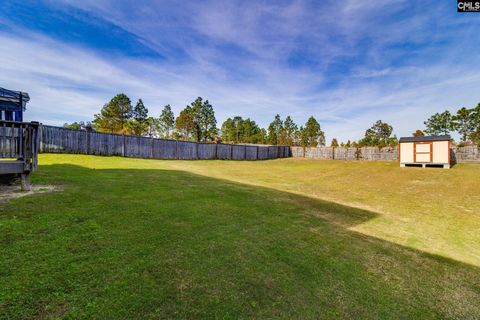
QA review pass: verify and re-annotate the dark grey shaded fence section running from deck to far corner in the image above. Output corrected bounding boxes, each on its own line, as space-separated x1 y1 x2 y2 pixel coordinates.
40 125 290 160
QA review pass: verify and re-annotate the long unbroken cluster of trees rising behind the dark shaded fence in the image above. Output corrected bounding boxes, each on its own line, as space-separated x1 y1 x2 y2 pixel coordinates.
64 93 325 147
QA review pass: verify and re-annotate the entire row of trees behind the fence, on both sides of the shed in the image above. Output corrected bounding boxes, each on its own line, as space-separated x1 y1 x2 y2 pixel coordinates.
64 93 480 147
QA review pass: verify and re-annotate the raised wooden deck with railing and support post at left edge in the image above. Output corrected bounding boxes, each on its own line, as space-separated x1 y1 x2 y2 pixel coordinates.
0 121 39 190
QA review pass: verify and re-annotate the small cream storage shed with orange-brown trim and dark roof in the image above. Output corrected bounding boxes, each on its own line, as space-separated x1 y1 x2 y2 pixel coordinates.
398 135 451 169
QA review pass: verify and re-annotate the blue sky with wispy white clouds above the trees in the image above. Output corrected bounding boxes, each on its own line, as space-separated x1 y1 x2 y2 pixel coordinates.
0 0 480 141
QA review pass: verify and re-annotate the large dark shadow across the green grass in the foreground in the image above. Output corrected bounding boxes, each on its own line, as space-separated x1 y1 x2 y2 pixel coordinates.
0 165 480 319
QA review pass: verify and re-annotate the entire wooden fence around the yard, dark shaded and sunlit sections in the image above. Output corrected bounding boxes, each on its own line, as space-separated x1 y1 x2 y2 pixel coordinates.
34 125 480 163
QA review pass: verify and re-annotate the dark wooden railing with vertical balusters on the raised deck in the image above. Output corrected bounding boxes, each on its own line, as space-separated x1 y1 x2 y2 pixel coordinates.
0 120 40 172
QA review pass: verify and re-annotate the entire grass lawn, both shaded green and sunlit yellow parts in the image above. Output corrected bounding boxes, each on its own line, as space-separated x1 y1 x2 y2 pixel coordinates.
0 155 480 319
